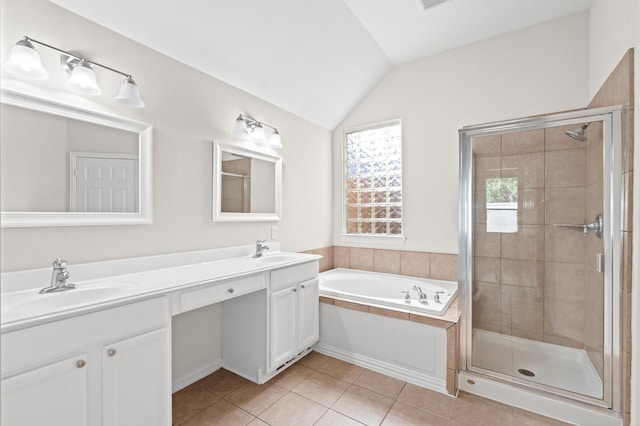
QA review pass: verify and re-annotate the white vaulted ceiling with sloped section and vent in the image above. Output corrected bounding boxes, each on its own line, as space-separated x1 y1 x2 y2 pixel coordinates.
51 0 591 129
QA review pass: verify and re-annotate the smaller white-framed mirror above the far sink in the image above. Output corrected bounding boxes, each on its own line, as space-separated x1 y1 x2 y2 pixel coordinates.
213 141 282 222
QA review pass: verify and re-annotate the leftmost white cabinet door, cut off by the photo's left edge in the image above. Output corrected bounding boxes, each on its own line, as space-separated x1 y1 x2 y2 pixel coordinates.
2 353 89 426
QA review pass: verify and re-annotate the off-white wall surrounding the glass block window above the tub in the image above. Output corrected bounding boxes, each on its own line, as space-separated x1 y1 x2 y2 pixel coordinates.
333 12 589 253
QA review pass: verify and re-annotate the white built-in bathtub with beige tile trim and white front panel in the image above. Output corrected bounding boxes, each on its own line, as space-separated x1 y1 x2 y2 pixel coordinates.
314 268 459 394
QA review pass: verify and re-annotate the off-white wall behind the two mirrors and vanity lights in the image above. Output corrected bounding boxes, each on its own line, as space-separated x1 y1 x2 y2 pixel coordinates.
0 0 332 271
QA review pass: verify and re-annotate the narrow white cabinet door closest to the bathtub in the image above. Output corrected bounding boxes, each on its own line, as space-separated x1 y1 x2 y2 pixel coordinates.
298 278 320 351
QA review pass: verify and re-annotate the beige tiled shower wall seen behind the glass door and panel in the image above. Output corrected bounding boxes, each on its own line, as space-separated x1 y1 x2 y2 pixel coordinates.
473 126 602 364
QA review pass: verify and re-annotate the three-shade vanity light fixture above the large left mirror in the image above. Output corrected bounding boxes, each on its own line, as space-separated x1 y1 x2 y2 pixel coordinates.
4 36 144 108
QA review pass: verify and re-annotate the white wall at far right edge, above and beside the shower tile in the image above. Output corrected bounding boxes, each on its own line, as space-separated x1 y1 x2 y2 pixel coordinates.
589 0 640 425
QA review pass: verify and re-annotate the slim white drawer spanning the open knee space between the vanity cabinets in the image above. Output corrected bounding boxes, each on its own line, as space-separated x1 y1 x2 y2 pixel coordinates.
172 274 266 315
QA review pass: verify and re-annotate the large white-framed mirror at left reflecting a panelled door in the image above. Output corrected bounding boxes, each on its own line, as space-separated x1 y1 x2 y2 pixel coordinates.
0 89 153 227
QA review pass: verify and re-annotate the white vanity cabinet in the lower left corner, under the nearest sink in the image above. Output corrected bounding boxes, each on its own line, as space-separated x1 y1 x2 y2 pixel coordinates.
1 297 171 426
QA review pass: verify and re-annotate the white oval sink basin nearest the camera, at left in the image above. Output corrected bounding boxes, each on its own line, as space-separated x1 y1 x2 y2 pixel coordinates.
3 282 134 312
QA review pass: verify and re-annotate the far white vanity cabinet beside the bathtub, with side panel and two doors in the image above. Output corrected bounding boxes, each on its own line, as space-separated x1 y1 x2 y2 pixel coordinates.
222 259 319 384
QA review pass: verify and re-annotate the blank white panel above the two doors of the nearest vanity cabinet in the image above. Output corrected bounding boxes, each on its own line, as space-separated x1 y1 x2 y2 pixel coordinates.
1 296 170 379
